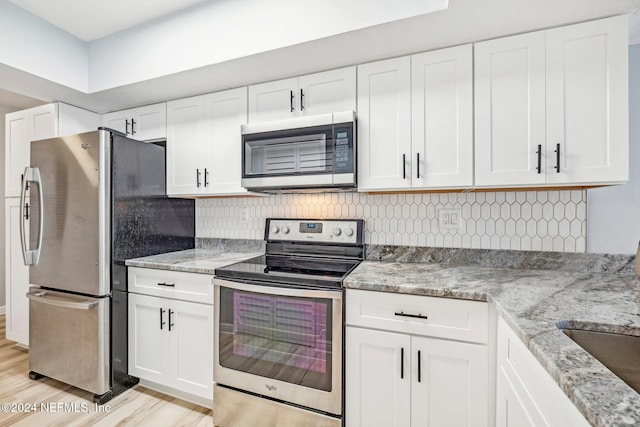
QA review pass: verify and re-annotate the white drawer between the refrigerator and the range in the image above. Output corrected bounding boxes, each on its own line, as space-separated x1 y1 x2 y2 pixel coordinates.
128 267 213 305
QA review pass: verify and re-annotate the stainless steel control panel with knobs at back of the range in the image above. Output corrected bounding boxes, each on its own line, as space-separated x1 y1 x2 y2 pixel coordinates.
265 218 363 245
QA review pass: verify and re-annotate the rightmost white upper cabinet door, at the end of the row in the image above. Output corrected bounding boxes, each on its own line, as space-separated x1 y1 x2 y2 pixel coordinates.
547 16 629 184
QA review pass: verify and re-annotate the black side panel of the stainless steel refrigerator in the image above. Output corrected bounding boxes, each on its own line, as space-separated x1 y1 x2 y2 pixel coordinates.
111 132 195 394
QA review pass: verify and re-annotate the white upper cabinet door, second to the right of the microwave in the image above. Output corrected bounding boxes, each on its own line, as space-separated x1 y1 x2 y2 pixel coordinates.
411 45 473 188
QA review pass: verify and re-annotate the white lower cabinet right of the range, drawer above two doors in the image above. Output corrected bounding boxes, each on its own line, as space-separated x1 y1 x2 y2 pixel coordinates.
345 289 493 427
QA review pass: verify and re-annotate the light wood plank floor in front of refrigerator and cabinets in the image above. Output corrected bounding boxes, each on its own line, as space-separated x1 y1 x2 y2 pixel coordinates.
0 315 213 427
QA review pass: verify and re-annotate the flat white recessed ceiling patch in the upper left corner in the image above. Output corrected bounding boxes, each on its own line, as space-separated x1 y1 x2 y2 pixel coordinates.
9 0 207 41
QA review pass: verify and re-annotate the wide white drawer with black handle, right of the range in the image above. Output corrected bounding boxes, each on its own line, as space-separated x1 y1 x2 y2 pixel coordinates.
346 289 489 344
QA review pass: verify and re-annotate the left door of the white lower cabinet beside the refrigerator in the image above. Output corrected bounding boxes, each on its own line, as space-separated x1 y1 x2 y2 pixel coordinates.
129 293 170 384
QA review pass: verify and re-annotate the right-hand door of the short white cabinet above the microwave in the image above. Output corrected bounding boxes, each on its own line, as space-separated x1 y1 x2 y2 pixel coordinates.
297 67 356 116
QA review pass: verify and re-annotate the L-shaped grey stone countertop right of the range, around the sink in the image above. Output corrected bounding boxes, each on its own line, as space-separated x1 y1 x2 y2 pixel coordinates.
345 261 640 426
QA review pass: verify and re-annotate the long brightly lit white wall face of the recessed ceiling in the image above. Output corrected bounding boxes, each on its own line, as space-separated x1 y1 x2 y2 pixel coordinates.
89 0 448 92
